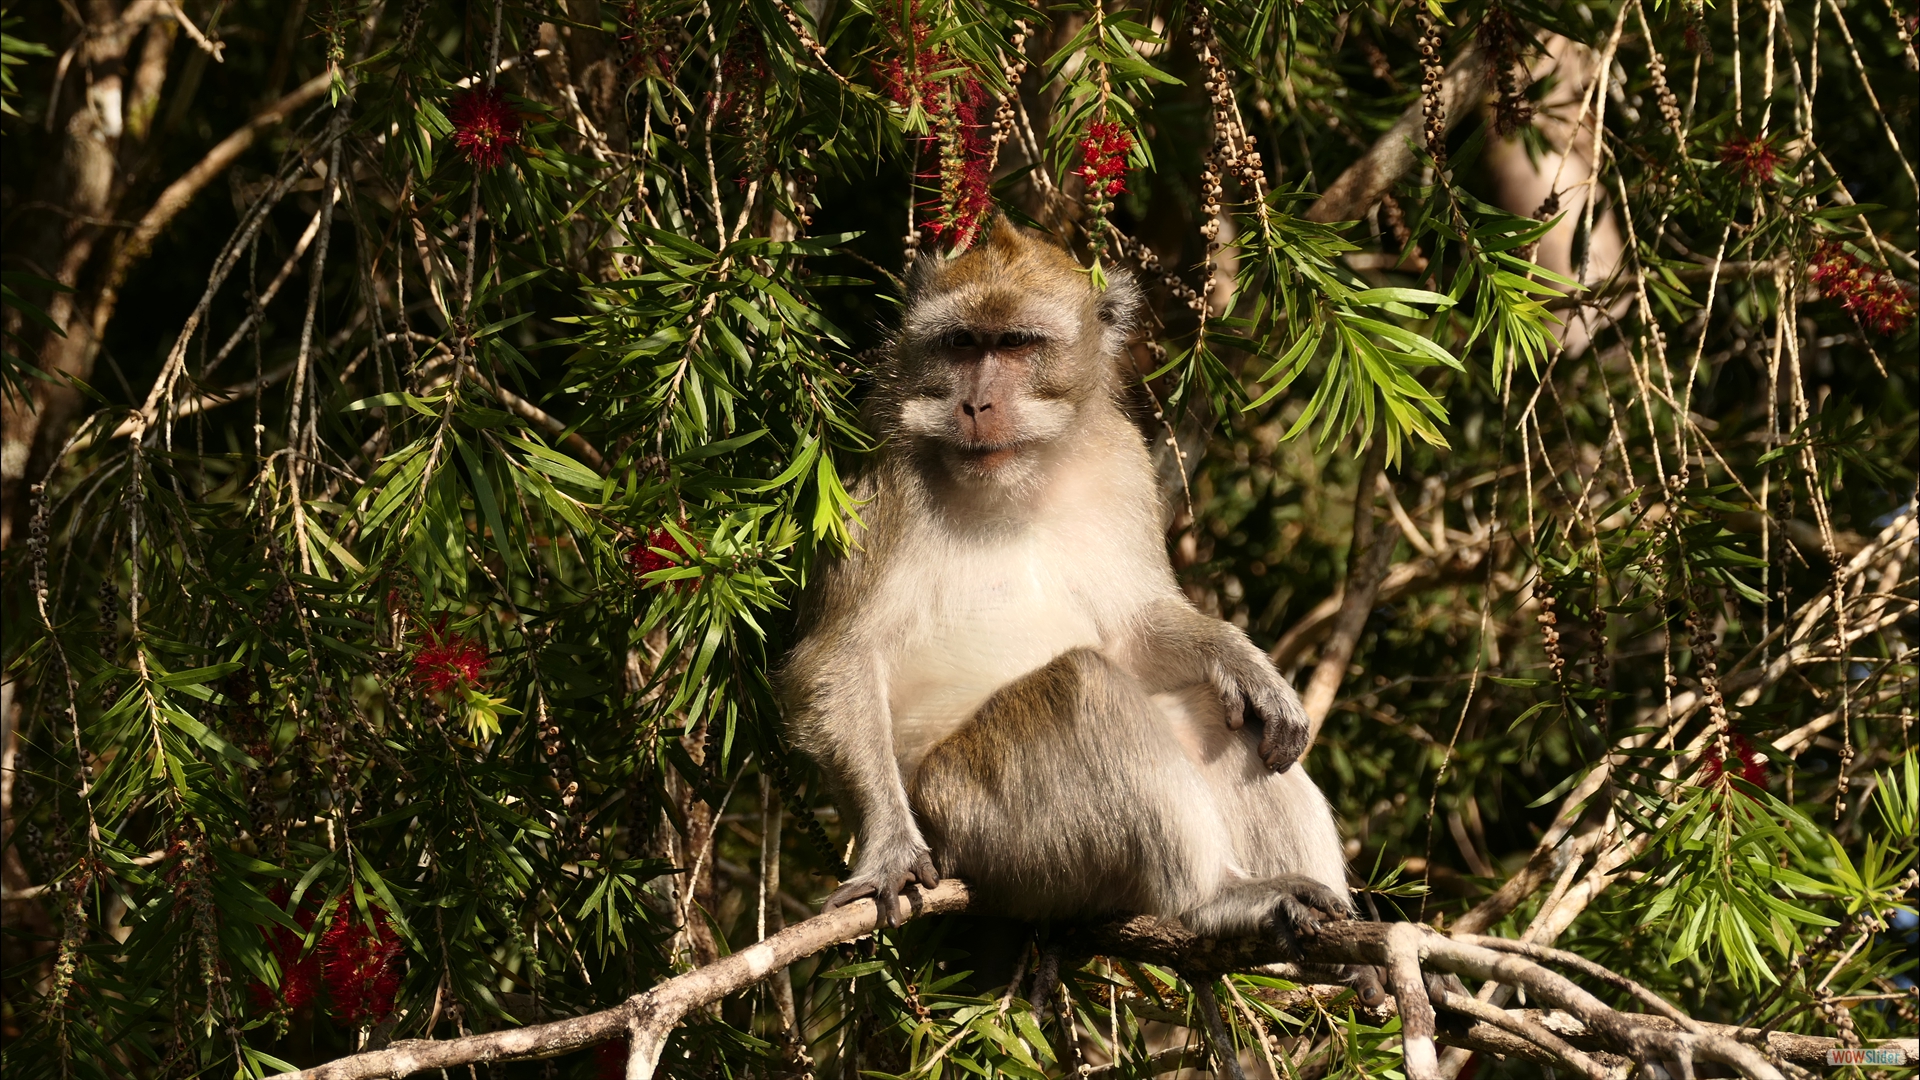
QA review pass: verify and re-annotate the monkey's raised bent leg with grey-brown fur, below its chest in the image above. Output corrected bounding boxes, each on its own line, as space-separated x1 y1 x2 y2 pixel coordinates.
910 650 1233 919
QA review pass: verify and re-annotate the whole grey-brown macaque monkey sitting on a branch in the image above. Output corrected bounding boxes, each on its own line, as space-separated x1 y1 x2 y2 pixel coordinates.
781 219 1379 968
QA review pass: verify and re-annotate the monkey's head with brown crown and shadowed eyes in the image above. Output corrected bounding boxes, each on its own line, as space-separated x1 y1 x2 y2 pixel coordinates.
881 217 1139 484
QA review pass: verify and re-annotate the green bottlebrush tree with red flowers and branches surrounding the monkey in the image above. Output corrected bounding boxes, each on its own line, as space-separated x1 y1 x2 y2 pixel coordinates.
0 0 1920 1080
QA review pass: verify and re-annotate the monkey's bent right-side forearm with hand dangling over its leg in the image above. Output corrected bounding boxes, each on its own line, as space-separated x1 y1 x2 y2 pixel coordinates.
1123 596 1309 773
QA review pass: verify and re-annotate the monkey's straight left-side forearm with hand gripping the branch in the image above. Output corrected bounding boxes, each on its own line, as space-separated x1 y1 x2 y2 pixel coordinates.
785 634 941 922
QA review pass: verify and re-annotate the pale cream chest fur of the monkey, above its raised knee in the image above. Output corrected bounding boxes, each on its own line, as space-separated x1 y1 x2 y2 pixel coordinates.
876 530 1150 776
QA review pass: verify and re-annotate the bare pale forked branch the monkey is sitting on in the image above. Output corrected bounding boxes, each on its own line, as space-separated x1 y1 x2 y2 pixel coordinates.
259 880 1920 1080
